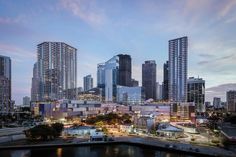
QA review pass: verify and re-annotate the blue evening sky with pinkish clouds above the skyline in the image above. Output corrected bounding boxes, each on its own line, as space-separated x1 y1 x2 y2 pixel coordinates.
0 0 236 104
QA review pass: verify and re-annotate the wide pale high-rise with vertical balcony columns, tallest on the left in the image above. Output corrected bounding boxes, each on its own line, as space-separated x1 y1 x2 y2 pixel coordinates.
37 42 77 101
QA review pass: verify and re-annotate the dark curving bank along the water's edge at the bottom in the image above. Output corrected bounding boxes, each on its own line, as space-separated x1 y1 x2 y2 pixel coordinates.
0 137 233 157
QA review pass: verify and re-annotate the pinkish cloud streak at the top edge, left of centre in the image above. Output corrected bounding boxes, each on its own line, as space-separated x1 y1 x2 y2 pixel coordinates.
61 0 105 26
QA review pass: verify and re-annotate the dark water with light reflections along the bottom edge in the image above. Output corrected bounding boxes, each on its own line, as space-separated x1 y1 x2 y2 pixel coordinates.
0 144 193 157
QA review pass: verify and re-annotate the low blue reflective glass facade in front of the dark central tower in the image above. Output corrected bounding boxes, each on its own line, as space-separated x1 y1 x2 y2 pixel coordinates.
116 86 144 105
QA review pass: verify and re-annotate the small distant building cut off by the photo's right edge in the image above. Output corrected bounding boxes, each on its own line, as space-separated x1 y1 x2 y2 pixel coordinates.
226 90 236 112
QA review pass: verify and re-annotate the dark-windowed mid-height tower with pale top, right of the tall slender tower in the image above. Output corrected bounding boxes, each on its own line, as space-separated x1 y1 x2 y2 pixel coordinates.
187 77 206 112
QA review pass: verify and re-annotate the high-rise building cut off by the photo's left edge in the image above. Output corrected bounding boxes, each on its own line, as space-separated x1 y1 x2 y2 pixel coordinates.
0 55 13 114
